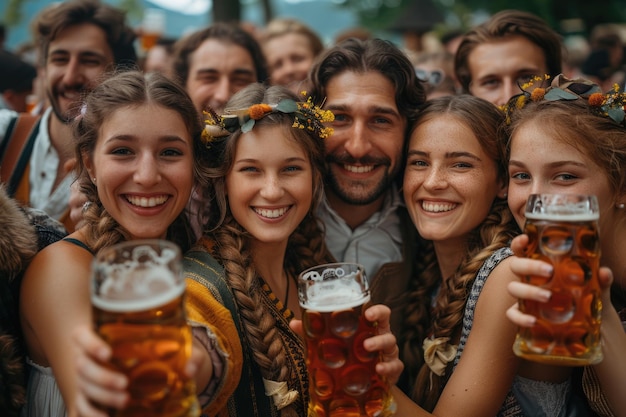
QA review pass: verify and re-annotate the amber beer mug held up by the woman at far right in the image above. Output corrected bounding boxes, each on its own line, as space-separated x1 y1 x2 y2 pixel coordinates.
513 194 603 366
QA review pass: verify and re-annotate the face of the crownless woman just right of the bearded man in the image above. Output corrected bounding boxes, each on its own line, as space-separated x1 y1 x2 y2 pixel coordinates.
403 114 505 244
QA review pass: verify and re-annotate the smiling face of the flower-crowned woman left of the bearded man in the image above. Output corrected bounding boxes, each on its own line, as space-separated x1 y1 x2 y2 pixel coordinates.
226 126 313 247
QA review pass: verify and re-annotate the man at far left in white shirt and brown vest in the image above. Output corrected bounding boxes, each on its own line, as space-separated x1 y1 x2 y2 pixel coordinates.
0 0 136 231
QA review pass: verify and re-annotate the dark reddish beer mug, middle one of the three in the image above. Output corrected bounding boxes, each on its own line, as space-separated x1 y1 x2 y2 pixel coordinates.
298 263 395 417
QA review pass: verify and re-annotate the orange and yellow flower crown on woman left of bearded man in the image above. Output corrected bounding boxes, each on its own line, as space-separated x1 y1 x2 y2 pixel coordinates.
202 91 335 146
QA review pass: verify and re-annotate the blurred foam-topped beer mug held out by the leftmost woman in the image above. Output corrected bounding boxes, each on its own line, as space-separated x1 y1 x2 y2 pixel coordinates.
91 240 200 417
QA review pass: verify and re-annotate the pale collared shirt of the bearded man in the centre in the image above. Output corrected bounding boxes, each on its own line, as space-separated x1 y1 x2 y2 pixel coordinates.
317 186 404 279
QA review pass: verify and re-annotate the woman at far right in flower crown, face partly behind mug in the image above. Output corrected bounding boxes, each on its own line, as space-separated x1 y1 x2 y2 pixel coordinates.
500 75 626 416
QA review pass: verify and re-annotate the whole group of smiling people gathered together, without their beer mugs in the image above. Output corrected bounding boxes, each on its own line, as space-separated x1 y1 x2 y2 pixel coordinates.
0 0 626 417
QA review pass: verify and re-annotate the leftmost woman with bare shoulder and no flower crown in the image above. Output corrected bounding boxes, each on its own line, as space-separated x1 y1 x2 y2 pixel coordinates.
15 71 203 417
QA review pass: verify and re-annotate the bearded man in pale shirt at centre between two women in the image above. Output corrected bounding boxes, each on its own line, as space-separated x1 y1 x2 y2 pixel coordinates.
310 39 425 334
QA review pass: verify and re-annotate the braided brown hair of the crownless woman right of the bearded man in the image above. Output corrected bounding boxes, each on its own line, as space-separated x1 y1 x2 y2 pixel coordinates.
402 95 519 411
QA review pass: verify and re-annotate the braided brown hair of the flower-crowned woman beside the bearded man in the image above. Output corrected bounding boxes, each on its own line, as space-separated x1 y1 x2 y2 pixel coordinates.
205 84 332 417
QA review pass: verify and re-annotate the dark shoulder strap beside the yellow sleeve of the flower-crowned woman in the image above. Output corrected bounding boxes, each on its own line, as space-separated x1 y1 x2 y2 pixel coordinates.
183 250 269 417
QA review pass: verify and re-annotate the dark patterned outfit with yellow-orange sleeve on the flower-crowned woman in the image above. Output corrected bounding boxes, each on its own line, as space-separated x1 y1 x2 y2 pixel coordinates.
184 242 309 417
